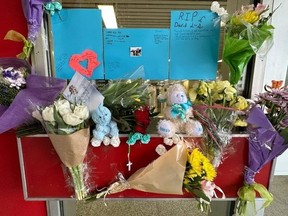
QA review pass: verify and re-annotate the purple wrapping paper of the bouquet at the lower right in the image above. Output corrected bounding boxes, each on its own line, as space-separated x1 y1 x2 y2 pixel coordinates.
244 107 288 184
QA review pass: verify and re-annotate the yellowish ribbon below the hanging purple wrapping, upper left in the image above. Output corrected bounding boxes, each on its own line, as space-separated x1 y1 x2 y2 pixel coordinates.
4 30 33 60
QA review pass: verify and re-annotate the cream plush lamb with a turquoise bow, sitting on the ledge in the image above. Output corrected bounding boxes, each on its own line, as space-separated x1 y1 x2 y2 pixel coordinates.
157 83 203 144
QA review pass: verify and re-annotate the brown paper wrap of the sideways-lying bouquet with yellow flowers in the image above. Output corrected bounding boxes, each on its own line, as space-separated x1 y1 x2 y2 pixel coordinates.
107 141 187 195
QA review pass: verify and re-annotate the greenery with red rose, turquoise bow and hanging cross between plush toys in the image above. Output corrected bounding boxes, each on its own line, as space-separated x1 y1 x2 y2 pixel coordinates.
101 75 158 171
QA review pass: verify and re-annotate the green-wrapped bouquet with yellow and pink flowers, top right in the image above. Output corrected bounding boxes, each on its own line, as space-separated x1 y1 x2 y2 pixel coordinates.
211 2 274 85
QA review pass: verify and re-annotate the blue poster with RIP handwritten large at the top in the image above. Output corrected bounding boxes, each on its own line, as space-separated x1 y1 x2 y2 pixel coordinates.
169 10 220 80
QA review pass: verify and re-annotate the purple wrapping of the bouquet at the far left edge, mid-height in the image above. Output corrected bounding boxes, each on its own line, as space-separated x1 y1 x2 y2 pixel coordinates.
0 75 66 133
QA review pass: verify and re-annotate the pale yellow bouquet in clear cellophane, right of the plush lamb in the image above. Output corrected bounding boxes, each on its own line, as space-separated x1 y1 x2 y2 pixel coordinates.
189 80 248 167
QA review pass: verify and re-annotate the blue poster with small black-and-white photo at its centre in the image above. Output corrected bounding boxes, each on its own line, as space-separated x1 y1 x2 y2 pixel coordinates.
104 28 169 80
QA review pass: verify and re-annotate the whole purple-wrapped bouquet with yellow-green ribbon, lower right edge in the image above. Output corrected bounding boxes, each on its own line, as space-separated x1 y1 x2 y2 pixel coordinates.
236 81 288 216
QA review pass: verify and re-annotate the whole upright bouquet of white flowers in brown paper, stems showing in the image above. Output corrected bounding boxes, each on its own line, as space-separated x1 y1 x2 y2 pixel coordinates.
34 97 90 200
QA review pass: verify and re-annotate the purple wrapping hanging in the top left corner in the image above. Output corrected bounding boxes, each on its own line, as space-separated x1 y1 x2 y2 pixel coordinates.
22 0 52 44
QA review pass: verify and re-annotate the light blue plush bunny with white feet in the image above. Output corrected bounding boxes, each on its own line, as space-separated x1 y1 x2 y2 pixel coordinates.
91 104 120 147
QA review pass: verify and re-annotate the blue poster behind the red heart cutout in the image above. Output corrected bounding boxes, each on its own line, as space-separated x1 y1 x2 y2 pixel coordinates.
51 9 104 79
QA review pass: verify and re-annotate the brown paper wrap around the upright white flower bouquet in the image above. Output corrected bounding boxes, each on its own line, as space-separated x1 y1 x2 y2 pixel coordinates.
48 128 90 167
